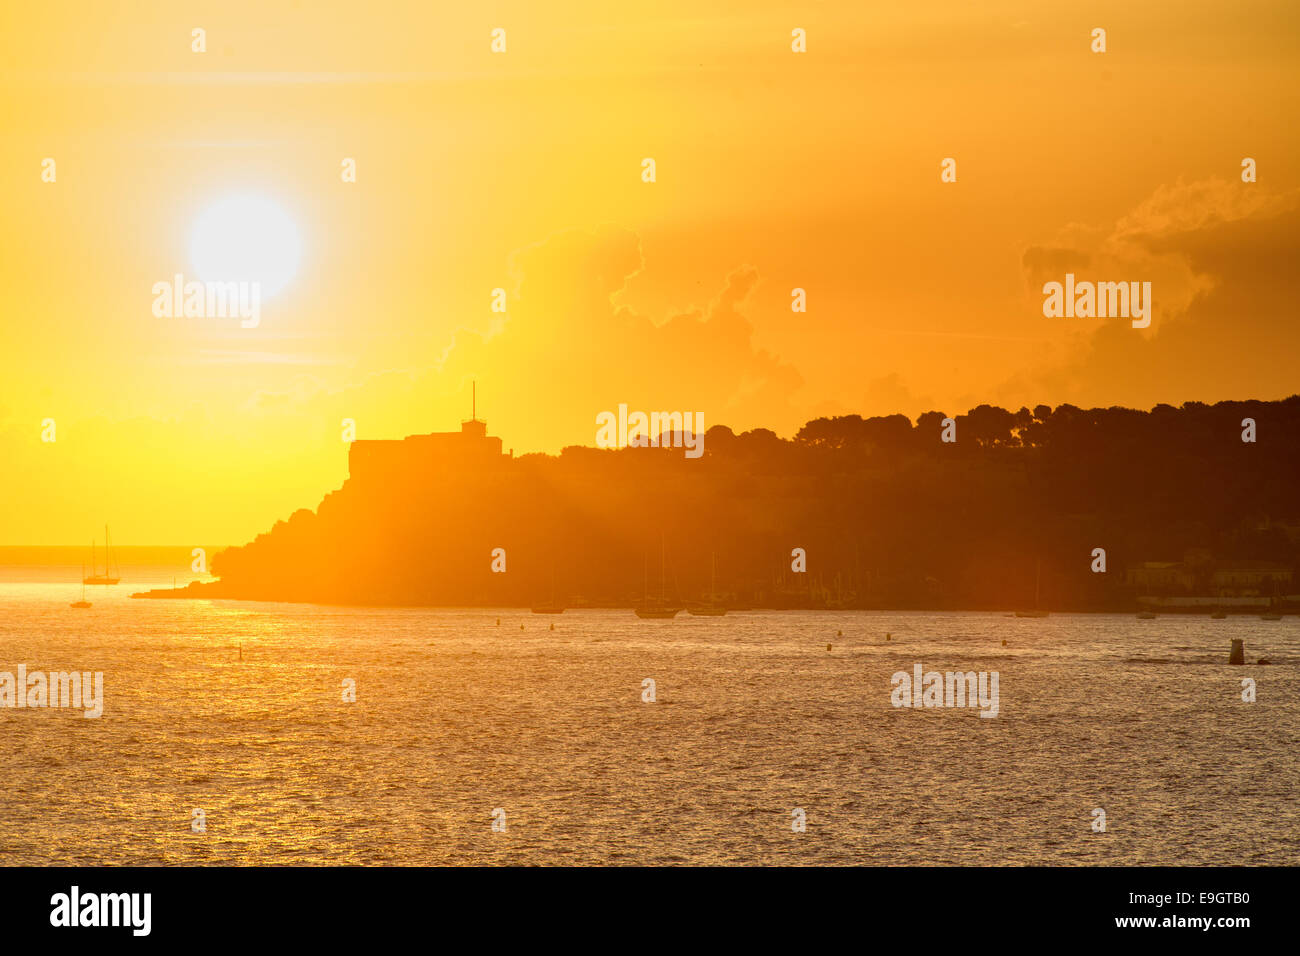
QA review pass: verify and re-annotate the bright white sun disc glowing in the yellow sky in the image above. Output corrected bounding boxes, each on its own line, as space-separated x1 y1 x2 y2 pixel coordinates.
190 196 303 298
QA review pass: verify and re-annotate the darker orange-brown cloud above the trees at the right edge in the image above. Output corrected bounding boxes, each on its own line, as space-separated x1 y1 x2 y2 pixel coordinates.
1019 179 1300 406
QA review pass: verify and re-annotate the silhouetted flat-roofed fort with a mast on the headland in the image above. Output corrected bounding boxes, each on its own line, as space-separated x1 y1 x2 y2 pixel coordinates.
347 385 515 483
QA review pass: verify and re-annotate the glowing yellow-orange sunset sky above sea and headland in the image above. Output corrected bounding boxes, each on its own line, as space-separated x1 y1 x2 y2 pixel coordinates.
0 0 1300 544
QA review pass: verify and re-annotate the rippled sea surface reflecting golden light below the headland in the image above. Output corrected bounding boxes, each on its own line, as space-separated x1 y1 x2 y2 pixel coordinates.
0 567 1300 865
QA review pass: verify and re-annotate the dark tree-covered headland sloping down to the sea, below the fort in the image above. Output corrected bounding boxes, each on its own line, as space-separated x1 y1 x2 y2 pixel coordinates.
211 395 1300 610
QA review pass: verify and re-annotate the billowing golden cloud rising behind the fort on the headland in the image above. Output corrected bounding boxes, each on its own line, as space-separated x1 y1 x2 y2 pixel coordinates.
439 226 802 447
